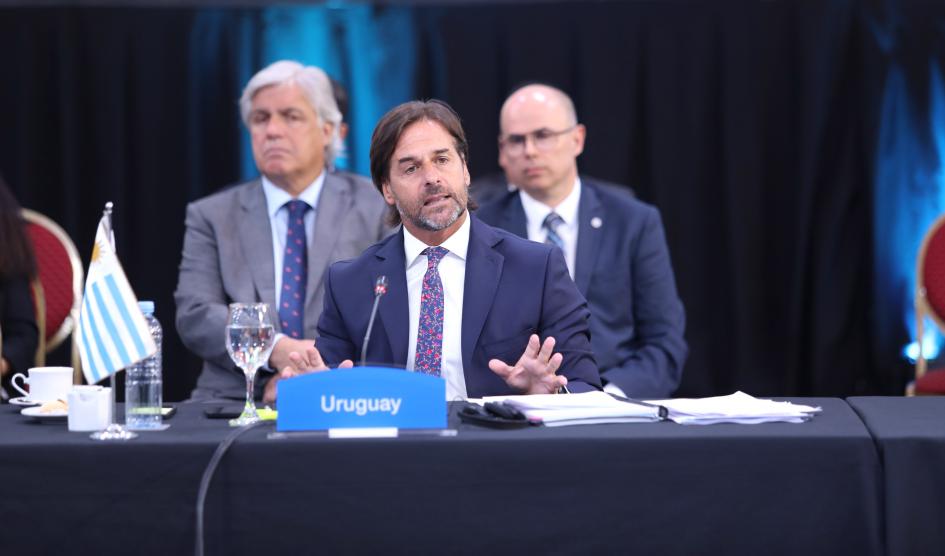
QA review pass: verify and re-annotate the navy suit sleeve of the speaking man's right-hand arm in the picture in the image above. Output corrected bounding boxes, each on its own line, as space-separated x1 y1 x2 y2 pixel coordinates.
540 245 601 393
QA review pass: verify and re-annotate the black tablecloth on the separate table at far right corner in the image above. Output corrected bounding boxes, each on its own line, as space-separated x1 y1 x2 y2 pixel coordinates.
848 396 945 556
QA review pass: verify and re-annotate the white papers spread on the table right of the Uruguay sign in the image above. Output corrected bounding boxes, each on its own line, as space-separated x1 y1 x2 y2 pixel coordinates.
480 392 821 427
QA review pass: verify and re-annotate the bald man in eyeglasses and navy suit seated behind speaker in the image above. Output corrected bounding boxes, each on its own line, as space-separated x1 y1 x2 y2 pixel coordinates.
477 84 688 398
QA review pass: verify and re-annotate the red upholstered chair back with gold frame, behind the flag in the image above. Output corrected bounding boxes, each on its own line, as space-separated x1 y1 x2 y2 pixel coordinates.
23 209 84 383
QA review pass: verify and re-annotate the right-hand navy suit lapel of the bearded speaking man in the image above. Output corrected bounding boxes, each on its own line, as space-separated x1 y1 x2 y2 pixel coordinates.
462 217 506 374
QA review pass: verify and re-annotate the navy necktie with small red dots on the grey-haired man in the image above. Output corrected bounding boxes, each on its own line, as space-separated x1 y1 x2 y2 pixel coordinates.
279 199 312 338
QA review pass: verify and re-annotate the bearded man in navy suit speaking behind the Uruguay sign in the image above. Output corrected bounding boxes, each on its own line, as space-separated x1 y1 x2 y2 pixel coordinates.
269 100 600 400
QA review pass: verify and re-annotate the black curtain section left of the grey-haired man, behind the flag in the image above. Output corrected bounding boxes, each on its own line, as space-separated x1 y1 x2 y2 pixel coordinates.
0 8 254 400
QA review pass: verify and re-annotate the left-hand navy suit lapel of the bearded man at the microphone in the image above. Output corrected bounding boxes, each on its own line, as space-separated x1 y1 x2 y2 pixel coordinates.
369 229 410 364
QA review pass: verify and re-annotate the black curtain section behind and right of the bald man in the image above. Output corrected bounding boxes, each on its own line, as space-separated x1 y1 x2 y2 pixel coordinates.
420 0 878 395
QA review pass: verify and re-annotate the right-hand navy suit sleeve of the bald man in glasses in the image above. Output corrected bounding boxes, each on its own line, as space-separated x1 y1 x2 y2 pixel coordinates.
601 206 688 398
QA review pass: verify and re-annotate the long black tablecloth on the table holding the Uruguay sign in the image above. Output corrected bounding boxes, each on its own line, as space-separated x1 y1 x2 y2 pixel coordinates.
0 399 882 556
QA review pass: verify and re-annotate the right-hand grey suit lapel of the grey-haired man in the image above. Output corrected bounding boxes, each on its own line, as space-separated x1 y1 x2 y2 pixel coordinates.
305 176 350 319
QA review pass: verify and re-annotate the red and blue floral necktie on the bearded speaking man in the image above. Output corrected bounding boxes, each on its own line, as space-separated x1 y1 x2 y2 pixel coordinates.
413 247 449 376
